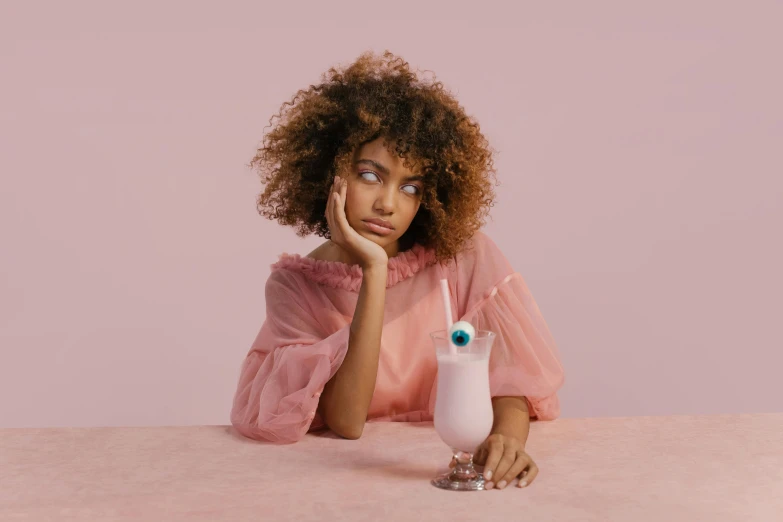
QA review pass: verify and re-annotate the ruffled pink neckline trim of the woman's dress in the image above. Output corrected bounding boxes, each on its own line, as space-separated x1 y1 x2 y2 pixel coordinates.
272 243 436 292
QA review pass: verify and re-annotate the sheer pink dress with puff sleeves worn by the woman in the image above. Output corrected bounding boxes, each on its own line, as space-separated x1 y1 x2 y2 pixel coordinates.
231 232 564 443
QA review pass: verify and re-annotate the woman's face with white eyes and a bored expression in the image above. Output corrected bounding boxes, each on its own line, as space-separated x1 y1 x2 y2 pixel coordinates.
345 138 424 257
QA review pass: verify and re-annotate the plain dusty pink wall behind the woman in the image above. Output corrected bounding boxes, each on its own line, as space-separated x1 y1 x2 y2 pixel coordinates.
0 1 783 427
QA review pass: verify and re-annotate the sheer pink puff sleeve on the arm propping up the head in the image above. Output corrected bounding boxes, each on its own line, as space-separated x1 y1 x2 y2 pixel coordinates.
231 270 350 443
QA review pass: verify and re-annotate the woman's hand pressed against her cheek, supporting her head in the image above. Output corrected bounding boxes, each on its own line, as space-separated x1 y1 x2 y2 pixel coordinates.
326 177 389 269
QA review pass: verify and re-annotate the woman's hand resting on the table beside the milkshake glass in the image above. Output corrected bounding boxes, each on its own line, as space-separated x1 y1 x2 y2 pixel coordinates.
449 434 538 489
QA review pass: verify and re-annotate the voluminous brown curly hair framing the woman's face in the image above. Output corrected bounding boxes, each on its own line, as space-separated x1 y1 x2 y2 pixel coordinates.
248 51 497 261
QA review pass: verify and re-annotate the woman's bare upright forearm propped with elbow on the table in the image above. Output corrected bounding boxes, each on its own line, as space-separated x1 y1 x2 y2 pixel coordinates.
318 265 387 439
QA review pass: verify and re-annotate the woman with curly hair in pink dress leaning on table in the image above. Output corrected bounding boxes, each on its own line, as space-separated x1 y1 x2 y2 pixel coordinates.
231 51 563 489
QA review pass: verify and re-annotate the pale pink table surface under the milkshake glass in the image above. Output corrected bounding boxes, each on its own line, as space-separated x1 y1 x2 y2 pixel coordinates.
0 414 783 522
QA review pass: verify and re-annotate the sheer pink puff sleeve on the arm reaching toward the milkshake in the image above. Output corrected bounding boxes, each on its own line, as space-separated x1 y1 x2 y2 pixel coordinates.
457 234 565 420
